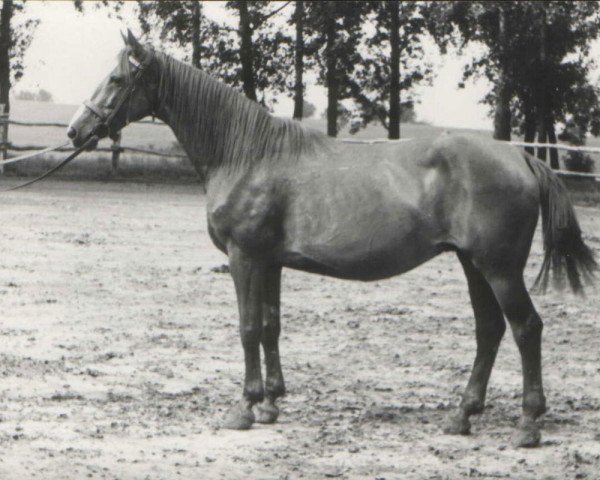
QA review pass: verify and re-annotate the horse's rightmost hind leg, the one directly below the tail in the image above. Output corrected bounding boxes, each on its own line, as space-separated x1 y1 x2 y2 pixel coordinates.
486 272 546 447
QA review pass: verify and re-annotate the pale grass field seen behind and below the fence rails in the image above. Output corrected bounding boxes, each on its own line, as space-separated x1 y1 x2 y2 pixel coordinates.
6 100 600 203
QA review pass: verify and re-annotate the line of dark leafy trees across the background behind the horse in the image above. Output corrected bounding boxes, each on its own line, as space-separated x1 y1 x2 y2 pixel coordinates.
0 0 600 168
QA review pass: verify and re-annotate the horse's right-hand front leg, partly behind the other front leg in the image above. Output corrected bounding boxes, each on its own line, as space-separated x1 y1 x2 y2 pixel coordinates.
256 266 285 423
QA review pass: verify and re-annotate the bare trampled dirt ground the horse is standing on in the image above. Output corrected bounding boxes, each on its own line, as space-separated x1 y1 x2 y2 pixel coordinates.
0 182 600 480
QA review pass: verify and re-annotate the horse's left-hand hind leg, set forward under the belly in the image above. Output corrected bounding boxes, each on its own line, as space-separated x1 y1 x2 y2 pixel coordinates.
444 253 506 435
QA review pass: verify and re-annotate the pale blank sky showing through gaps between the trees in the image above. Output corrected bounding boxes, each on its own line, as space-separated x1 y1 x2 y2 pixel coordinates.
14 0 492 129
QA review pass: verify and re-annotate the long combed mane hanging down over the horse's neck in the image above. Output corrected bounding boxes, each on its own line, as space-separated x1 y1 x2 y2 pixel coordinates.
150 53 329 170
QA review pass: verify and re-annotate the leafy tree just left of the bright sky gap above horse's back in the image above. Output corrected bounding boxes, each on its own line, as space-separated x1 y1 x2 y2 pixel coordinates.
351 0 431 139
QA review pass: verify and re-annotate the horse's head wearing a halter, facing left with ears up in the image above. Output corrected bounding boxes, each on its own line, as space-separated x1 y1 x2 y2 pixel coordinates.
67 30 156 148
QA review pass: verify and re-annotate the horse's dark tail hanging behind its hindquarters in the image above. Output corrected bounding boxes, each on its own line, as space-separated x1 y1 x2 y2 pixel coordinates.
525 154 598 293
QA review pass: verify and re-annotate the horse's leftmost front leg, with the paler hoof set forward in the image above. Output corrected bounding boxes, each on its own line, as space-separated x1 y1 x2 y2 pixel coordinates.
224 246 266 430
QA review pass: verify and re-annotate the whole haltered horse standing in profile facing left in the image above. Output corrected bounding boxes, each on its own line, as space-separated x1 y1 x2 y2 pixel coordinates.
67 31 597 447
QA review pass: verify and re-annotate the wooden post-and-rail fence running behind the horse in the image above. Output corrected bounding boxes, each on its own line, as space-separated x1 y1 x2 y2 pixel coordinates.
0 104 600 181
